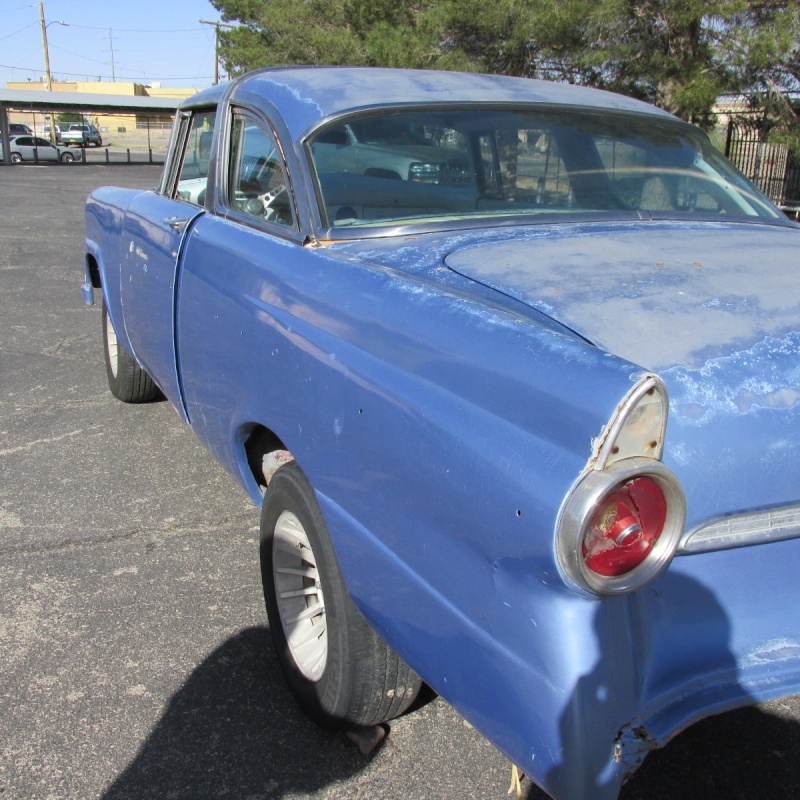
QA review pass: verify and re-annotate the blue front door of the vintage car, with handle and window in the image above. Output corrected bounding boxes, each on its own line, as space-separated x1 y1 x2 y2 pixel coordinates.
120 110 216 418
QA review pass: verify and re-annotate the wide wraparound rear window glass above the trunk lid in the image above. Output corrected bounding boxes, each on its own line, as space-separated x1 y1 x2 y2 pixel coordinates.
308 109 782 227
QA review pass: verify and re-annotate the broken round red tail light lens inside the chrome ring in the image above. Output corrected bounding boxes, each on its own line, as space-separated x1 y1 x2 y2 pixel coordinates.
582 476 667 577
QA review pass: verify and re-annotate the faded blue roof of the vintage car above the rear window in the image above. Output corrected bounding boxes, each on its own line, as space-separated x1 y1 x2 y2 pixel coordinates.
182 67 671 138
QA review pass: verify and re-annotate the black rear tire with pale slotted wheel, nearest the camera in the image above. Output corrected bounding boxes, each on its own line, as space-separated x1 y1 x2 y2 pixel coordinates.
261 462 421 729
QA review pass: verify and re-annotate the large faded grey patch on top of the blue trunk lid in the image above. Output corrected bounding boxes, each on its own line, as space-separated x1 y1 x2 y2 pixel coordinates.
438 222 800 372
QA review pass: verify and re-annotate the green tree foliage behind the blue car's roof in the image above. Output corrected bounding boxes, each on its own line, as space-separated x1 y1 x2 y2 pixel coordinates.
211 0 800 130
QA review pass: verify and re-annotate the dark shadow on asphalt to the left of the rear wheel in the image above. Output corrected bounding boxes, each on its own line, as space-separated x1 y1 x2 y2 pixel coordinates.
103 627 369 800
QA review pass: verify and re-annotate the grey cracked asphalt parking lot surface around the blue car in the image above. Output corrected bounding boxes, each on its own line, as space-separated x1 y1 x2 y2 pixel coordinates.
0 164 800 800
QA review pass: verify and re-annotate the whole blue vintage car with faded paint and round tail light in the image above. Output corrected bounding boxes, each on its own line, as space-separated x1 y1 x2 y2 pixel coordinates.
84 68 800 800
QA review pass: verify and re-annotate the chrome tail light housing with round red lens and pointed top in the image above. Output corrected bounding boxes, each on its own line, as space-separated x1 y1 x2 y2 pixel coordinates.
556 375 686 594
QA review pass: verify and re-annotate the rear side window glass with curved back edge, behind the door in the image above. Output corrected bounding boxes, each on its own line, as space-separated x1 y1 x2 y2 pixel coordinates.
228 114 294 227
